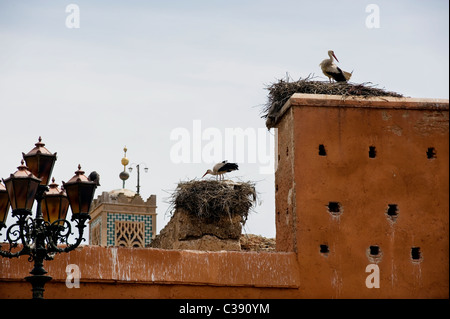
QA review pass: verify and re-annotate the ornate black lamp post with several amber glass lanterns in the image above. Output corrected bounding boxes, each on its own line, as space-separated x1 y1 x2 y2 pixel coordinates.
0 137 97 299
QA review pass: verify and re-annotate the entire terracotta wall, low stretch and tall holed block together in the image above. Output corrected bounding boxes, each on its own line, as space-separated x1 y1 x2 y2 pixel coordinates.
0 94 449 298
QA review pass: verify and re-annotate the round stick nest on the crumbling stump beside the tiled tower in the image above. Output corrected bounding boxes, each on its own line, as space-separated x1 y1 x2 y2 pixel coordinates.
169 180 257 224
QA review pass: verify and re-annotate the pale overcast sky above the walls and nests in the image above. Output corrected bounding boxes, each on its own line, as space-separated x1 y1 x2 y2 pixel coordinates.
0 0 449 239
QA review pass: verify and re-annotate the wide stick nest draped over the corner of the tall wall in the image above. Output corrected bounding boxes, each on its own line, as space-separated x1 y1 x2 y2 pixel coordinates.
262 75 403 129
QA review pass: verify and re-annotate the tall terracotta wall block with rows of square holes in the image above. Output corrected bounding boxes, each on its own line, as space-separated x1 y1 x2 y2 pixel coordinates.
275 94 449 298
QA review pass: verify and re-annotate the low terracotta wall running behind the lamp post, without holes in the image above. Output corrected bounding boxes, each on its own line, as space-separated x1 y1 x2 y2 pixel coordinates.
0 246 299 299
